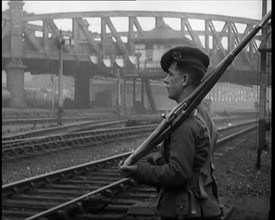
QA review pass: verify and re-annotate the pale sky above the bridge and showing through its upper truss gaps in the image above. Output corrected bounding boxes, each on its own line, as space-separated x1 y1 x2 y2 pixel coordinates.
2 0 271 33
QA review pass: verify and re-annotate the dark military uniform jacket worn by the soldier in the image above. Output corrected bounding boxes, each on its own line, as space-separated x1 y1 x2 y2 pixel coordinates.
134 105 220 217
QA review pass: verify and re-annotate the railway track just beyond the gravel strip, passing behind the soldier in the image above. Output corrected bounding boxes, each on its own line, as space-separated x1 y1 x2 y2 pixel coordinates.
2 121 255 161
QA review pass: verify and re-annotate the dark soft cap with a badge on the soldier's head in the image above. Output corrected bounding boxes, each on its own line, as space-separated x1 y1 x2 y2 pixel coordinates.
160 46 209 73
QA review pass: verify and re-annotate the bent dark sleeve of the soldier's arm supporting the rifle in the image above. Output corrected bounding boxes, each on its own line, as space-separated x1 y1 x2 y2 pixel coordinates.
134 119 208 187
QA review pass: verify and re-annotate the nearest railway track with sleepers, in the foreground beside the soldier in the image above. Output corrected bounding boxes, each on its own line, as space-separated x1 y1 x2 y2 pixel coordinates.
2 123 257 220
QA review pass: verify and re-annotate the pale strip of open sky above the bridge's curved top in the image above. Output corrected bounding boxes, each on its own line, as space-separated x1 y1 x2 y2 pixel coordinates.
2 0 271 19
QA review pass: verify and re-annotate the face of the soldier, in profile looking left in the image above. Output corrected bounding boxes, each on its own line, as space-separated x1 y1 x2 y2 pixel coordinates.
163 63 187 102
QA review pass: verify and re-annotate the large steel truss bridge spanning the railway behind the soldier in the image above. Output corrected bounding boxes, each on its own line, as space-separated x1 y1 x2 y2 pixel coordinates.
2 1 262 109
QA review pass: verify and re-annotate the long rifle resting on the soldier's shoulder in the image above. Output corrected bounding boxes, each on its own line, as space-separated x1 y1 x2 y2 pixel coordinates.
124 11 271 165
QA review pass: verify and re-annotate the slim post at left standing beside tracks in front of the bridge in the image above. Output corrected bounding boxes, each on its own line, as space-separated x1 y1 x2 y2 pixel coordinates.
57 30 65 125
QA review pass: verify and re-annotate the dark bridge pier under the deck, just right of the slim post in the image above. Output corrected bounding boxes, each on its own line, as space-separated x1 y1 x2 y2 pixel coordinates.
74 71 90 109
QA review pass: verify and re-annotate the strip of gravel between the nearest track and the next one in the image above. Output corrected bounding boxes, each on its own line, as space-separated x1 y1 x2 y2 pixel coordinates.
2 137 146 185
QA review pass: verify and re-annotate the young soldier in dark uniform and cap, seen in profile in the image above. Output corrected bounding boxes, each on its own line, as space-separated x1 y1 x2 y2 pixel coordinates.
119 46 221 220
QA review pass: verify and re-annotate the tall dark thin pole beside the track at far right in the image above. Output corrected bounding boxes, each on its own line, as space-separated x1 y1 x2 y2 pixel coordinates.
256 0 267 169
